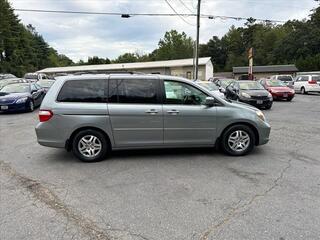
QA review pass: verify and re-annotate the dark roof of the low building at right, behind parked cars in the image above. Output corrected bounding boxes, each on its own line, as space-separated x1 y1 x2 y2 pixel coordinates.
233 64 298 73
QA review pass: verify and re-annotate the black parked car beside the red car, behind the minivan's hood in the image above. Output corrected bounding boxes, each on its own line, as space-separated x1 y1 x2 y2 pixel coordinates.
225 81 273 109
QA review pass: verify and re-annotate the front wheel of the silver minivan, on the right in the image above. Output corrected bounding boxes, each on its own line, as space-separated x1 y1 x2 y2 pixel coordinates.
221 124 255 156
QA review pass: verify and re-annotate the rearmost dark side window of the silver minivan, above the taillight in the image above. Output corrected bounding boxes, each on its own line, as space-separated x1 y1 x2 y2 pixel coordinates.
57 79 106 103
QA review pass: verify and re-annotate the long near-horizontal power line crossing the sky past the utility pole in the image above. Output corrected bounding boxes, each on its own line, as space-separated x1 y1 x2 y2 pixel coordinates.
14 8 286 23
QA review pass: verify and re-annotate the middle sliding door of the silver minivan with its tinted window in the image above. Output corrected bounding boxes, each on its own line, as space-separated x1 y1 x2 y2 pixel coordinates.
108 76 163 147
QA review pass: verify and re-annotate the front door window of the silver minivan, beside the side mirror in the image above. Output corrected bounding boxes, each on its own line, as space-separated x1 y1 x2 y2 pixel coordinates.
164 81 207 105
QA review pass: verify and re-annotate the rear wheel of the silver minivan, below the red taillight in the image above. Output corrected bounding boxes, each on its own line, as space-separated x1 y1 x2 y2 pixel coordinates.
72 129 110 162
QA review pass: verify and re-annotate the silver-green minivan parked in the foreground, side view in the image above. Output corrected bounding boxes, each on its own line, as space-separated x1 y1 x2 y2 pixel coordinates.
36 73 270 162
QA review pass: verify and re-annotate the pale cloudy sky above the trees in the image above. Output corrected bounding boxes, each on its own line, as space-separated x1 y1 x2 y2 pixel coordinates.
9 0 319 62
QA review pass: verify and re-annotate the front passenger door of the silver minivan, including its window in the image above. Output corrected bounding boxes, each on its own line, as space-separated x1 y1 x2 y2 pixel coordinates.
163 80 216 145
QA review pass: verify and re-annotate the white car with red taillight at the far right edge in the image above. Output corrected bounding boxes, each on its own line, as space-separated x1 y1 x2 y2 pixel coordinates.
293 75 320 94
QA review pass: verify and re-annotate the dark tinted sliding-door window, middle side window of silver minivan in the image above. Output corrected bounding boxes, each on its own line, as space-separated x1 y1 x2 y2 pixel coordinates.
108 79 159 103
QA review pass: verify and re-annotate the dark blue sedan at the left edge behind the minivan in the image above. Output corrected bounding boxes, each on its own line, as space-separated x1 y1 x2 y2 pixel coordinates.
0 83 45 112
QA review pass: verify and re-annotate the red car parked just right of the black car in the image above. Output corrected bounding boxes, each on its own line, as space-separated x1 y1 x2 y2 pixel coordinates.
260 79 295 101
